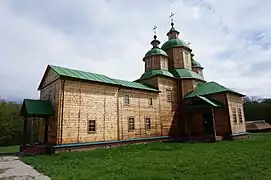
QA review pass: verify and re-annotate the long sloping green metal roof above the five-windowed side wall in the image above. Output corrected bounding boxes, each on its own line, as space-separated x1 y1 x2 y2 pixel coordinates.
46 65 158 92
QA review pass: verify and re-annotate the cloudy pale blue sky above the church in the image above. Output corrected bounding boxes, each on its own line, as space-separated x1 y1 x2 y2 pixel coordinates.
0 0 271 100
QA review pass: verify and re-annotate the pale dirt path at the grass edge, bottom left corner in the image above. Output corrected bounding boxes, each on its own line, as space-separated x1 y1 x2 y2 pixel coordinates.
0 156 50 180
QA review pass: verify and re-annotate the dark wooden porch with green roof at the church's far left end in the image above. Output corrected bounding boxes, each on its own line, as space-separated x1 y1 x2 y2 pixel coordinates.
20 99 54 155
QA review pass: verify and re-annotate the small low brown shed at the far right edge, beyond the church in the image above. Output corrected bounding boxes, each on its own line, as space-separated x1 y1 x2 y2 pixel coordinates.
246 120 271 132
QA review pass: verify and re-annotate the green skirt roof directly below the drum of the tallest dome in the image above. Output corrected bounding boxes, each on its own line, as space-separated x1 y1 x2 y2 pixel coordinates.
169 68 204 81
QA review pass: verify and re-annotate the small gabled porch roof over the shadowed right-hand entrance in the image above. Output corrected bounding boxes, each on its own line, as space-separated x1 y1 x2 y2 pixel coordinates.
187 95 224 108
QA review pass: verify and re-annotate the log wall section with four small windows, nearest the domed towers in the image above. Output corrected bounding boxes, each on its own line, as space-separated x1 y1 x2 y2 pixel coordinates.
119 89 161 139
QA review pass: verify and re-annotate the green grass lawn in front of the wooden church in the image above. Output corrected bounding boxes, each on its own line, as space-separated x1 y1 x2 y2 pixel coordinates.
23 133 271 180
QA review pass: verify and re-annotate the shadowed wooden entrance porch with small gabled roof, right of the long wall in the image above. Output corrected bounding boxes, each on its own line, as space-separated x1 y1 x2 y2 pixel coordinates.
184 96 231 142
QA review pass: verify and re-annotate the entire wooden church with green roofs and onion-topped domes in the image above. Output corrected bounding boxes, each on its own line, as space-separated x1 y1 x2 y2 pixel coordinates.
20 22 247 153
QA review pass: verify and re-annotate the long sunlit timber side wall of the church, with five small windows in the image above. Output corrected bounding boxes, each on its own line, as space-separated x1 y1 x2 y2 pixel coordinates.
58 80 161 144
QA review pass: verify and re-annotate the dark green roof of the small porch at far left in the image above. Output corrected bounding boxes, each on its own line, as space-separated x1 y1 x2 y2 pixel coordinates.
20 99 54 117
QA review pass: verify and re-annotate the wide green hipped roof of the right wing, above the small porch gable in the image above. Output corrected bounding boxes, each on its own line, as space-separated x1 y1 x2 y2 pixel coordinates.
184 81 244 98
